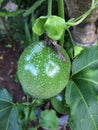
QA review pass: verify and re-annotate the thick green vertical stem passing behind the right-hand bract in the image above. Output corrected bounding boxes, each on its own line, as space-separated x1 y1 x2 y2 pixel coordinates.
58 0 65 47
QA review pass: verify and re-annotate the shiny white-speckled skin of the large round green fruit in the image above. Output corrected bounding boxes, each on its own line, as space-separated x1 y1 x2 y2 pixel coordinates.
18 41 70 99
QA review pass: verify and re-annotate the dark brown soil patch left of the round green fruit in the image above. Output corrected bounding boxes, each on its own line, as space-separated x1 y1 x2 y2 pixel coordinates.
0 43 25 102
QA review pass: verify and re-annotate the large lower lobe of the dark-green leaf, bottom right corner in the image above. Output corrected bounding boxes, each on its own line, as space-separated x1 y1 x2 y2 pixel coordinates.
66 80 98 130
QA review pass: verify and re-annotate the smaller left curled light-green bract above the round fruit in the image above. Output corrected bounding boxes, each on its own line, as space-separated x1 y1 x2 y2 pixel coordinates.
32 16 47 35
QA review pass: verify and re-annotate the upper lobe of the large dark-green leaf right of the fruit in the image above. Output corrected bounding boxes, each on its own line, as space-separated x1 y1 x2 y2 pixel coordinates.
72 46 98 75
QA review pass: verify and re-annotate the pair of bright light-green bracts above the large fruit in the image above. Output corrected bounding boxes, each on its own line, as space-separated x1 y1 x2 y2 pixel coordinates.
33 16 65 40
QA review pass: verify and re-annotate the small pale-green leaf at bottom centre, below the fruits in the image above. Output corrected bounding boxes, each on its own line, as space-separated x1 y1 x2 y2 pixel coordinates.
39 110 58 130
